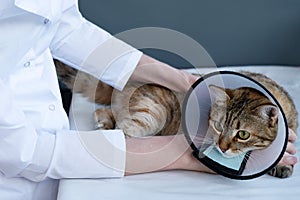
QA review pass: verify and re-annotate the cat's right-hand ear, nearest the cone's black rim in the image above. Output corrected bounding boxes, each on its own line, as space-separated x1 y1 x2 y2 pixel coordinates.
258 105 278 127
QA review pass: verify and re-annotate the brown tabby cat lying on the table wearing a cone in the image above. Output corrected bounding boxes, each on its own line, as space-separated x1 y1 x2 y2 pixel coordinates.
55 60 298 178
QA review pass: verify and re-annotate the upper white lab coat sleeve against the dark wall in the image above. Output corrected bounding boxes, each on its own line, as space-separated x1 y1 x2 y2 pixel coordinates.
50 1 142 90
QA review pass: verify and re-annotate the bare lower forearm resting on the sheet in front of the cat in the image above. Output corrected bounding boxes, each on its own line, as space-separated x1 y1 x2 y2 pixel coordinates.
125 135 211 175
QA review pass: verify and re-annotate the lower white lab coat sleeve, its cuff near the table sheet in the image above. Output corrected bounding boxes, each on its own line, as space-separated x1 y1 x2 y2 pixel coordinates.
0 80 125 181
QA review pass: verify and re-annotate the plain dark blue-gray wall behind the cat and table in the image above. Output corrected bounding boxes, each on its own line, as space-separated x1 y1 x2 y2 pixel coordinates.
79 0 300 67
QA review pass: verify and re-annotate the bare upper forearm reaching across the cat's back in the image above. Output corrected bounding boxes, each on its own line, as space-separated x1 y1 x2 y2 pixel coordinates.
131 55 198 92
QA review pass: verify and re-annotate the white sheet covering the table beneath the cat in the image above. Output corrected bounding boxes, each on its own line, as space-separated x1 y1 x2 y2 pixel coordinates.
58 66 300 200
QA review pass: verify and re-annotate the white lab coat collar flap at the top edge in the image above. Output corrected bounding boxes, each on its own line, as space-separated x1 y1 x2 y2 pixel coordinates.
14 0 63 21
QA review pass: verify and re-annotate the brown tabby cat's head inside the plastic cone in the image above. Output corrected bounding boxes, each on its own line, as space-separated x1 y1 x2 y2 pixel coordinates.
209 85 278 157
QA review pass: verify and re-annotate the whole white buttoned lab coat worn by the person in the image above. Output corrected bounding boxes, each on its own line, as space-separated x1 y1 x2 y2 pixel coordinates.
0 0 141 200
